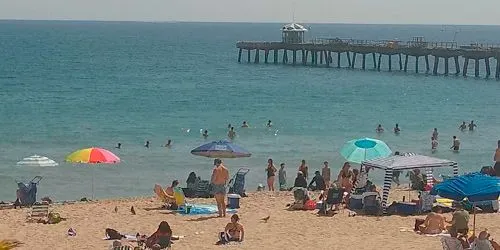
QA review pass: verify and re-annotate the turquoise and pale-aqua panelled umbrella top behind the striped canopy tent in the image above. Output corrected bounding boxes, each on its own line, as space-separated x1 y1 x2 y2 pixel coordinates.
340 138 392 164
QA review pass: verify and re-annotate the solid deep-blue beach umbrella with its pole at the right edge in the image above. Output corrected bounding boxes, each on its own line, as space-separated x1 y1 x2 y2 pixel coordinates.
430 173 500 233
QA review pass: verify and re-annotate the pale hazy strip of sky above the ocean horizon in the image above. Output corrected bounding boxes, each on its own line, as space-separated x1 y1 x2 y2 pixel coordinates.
0 0 500 25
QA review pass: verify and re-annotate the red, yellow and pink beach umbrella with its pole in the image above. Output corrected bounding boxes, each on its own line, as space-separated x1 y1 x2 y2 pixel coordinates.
66 148 120 199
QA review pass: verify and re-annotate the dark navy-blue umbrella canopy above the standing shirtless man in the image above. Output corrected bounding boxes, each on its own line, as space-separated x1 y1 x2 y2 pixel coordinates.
191 140 252 158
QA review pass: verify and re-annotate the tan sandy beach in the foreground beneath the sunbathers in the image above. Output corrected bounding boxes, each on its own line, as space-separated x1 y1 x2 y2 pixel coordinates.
0 190 500 249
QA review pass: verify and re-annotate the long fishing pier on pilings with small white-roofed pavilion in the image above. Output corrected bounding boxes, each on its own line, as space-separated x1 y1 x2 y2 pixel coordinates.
236 23 500 79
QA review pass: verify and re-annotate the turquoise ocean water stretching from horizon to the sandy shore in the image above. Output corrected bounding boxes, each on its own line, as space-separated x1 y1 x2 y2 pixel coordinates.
0 21 500 200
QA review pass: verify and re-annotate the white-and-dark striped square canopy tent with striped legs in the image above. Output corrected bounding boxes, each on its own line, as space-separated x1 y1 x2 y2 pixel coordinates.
362 153 458 213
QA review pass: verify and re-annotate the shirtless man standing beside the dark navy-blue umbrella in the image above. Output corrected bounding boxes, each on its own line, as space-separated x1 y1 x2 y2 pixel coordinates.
211 159 229 217
